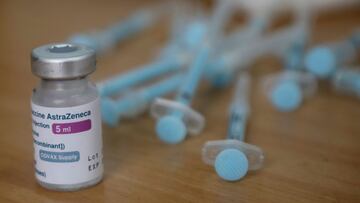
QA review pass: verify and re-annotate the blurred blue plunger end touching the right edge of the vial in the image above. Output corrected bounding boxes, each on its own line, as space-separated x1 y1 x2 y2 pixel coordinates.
101 98 119 127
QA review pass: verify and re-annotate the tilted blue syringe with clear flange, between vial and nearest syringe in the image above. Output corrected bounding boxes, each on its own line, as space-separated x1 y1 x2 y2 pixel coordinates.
151 20 211 144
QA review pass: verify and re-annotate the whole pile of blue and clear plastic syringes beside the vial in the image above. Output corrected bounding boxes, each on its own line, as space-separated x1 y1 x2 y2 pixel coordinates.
64 0 360 181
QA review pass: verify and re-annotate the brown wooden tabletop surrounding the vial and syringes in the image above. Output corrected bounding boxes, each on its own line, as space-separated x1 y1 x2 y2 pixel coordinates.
0 0 360 202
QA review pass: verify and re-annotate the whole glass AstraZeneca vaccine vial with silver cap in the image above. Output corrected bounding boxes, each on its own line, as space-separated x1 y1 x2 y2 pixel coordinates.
31 44 104 191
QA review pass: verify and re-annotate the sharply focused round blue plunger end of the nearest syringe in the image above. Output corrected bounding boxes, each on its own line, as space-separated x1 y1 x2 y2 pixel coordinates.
214 149 249 181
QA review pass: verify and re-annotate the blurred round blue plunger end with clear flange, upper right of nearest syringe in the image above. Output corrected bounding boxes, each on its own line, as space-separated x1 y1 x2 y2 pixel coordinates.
271 81 303 111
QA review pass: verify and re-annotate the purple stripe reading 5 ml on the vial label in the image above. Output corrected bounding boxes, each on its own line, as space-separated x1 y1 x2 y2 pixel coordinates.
52 119 91 135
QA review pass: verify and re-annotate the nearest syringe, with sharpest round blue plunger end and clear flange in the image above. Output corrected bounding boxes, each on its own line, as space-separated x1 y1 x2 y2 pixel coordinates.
202 73 264 181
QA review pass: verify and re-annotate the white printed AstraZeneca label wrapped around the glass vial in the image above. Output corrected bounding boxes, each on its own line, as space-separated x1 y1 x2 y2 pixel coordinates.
31 98 103 185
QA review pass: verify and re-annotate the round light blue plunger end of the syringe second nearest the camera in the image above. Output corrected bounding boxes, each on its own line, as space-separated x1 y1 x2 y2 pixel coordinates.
156 116 186 144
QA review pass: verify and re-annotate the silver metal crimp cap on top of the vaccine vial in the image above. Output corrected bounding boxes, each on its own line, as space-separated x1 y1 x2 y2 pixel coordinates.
31 43 96 79
